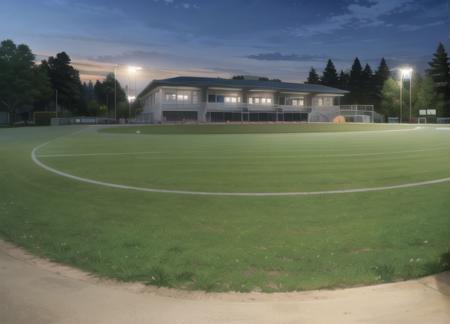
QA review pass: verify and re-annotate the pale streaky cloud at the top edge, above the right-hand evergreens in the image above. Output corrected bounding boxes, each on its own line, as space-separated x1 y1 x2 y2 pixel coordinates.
292 0 414 37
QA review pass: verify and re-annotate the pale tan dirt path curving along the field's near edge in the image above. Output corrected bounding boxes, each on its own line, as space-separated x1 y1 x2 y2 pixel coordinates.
0 241 450 324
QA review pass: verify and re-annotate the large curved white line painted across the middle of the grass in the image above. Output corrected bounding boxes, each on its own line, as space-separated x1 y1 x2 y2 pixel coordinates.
31 142 450 197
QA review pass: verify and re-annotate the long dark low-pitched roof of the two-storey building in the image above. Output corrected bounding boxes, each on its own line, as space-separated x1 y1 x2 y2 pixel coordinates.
139 77 348 96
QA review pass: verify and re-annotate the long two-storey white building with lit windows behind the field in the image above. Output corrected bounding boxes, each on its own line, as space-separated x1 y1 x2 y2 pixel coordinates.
139 76 347 123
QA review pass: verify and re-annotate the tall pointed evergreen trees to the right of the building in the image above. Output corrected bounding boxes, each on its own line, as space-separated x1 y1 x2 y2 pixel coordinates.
306 43 450 121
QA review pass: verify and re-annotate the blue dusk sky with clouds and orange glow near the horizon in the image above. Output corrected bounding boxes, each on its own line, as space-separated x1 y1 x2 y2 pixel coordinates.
0 0 449 92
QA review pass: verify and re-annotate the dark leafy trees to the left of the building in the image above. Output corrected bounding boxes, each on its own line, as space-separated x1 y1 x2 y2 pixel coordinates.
0 40 136 123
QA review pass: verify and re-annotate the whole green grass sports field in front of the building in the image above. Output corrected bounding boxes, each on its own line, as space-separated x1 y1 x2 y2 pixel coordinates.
0 124 450 292
